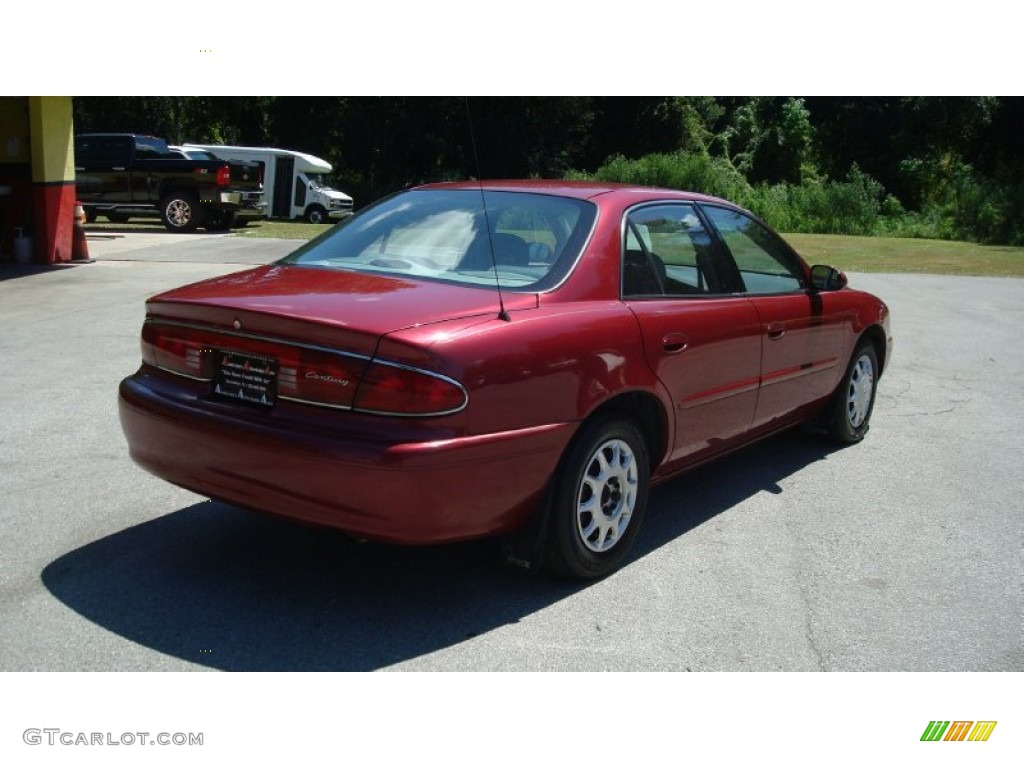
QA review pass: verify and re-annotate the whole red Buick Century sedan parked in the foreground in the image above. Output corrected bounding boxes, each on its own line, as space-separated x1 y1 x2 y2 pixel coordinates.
120 181 892 579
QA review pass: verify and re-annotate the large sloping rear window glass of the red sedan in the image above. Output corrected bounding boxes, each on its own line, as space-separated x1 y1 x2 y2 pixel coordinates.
279 189 596 291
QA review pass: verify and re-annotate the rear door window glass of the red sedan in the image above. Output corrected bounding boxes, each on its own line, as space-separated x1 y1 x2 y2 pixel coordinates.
623 204 720 297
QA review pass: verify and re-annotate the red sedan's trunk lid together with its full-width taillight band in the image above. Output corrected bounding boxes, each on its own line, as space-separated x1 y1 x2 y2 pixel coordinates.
142 265 537 415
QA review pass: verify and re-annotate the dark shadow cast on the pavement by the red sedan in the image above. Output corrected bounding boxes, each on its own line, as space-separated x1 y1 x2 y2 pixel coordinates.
42 433 835 671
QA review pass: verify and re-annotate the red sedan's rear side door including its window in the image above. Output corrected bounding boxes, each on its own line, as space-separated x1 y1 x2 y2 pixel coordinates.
622 202 762 462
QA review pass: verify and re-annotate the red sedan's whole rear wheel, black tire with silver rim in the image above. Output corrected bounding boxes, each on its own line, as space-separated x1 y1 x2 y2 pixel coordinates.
545 417 650 579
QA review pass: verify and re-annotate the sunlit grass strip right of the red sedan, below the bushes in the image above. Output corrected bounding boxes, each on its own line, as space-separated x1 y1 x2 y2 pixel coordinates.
783 234 1024 278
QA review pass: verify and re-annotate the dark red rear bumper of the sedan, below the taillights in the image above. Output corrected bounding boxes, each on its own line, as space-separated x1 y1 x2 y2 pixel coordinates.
119 374 573 544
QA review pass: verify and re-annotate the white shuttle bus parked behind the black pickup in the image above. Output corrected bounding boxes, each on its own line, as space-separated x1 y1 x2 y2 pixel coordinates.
182 144 352 224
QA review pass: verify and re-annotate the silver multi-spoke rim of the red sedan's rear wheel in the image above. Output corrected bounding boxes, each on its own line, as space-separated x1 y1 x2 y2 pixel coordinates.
577 440 639 552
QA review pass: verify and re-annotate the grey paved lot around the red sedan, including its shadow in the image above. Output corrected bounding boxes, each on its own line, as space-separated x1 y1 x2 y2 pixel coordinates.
0 233 1024 671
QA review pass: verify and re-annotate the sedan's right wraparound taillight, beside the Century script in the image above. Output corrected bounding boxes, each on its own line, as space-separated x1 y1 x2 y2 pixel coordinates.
353 362 467 416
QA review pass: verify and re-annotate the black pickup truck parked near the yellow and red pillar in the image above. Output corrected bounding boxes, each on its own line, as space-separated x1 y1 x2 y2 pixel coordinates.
75 133 264 232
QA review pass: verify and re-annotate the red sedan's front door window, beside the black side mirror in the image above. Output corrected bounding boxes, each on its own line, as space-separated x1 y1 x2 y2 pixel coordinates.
703 206 805 294
